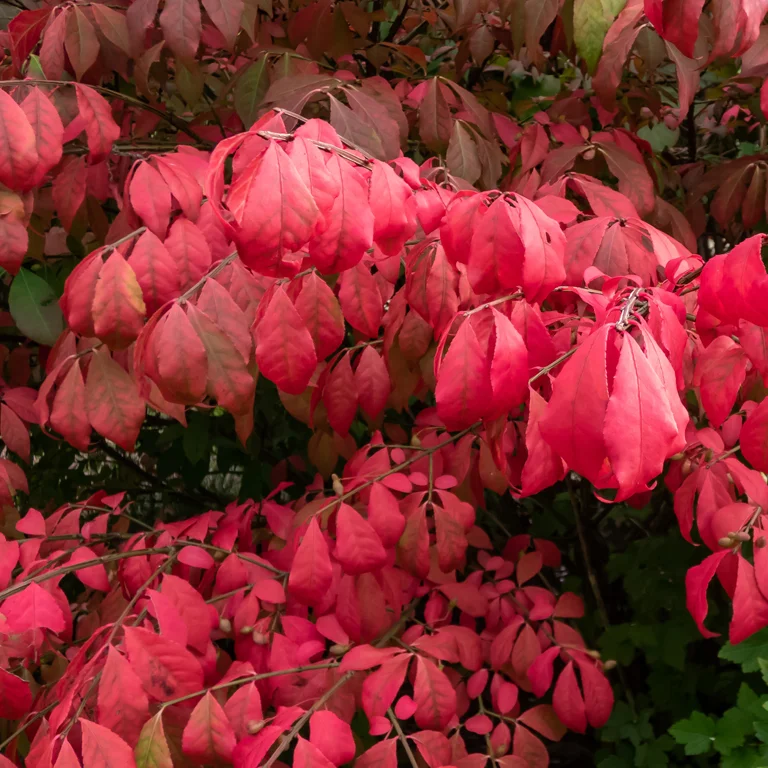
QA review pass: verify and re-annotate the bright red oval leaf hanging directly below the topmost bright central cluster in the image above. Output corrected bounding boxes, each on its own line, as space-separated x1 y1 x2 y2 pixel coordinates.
256 289 317 395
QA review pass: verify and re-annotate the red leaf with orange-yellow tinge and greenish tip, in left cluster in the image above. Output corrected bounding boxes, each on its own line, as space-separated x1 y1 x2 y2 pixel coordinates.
92 251 146 349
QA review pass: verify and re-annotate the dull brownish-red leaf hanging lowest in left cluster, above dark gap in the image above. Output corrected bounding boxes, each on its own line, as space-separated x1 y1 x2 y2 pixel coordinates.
85 349 146 451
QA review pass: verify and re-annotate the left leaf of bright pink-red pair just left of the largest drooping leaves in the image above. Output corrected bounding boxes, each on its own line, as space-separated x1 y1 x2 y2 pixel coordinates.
435 321 493 429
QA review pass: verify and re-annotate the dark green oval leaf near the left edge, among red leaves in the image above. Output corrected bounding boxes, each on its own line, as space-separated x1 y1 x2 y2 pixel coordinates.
8 269 64 347
